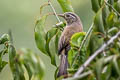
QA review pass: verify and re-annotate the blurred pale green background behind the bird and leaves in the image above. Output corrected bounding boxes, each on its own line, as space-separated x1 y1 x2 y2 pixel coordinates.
0 0 94 80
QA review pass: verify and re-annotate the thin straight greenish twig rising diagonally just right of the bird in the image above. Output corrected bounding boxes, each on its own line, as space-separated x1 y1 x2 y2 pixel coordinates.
72 23 94 66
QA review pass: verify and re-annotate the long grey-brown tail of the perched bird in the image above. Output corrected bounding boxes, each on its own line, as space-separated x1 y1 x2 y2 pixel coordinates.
57 51 68 77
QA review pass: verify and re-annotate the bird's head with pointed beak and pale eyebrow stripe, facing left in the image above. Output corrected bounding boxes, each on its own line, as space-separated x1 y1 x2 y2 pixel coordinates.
58 12 80 25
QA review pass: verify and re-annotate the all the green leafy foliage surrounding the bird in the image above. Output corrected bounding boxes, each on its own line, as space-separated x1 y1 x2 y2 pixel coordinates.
0 0 120 80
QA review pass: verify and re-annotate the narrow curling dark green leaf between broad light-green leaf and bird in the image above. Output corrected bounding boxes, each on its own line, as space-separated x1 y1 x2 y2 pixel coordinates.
46 28 58 66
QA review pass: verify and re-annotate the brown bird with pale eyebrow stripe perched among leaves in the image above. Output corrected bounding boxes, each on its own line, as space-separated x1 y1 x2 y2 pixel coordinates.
57 12 83 78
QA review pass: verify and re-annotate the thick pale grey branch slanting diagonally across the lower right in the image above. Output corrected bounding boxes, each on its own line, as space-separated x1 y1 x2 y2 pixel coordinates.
74 31 120 78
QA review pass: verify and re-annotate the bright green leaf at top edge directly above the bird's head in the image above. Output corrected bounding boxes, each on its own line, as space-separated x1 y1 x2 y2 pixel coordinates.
57 0 74 12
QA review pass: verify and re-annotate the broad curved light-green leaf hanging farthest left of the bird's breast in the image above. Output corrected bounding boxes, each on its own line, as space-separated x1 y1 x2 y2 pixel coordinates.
35 15 48 54
